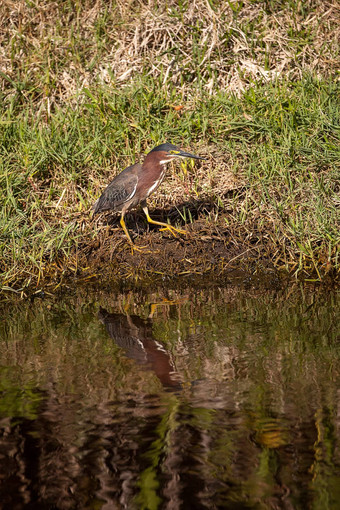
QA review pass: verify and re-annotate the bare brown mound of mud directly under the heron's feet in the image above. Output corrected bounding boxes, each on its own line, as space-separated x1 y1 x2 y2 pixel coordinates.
83 220 277 280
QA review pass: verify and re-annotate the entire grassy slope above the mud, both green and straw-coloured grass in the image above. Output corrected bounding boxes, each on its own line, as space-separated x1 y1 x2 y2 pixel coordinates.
0 2 340 289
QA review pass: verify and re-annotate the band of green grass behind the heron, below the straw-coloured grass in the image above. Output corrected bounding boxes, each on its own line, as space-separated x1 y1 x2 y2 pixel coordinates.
0 77 340 286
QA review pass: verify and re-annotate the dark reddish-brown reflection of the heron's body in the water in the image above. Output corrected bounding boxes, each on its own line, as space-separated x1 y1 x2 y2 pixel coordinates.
98 308 181 389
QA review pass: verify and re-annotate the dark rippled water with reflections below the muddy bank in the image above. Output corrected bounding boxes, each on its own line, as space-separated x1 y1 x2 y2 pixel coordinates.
0 282 340 510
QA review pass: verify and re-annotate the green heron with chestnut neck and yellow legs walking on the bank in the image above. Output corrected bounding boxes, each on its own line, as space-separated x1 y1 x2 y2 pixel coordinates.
93 143 204 246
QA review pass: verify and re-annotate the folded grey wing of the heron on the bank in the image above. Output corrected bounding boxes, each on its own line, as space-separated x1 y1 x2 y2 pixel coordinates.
93 164 141 214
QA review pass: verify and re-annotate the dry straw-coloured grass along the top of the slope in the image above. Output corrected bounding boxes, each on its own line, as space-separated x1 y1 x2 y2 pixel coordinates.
0 0 340 110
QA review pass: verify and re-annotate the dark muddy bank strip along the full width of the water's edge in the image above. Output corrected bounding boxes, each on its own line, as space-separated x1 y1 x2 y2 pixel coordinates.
3 214 339 298
